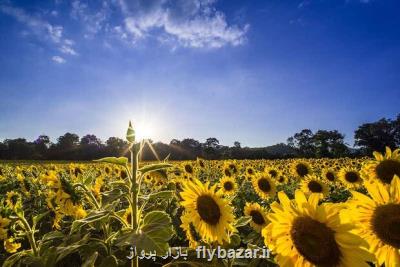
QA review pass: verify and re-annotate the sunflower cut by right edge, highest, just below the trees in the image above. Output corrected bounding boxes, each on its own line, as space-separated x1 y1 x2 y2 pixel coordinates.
360 147 400 185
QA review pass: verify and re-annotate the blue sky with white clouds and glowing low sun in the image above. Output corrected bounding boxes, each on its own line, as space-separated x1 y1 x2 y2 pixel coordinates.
0 0 400 146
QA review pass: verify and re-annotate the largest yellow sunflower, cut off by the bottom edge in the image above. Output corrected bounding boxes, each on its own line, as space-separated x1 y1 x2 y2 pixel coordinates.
262 190 373 267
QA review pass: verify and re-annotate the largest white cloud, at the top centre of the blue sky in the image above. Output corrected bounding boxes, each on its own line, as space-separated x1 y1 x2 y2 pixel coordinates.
116 0 249 48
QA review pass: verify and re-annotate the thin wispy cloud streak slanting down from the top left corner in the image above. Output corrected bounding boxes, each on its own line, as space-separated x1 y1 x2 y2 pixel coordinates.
0 4 78 60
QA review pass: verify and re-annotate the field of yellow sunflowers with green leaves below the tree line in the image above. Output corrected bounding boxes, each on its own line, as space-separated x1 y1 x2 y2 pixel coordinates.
0 124 400 267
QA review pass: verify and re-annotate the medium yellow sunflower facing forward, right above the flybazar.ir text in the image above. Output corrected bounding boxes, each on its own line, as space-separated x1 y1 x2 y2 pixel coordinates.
180 180 235 244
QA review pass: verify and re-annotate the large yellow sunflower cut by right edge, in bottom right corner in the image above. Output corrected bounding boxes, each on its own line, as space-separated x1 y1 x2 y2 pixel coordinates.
344 175 400 267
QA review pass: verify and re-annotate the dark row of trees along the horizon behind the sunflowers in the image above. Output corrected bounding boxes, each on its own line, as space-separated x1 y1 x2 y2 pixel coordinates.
0 114 400 160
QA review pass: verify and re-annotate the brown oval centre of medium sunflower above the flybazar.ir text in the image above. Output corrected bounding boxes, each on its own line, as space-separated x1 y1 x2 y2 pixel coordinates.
197 196 221 225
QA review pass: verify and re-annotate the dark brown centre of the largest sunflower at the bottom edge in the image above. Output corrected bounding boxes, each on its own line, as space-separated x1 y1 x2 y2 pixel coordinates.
290 216 341 266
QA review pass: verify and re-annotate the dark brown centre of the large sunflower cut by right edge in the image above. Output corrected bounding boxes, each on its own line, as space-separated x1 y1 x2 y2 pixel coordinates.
371 204 400 249
